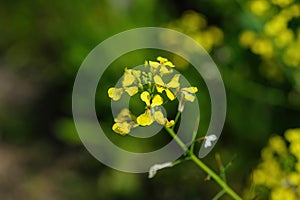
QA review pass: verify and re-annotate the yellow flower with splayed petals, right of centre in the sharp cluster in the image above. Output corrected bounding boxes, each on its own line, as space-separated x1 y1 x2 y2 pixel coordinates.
154 74 180 101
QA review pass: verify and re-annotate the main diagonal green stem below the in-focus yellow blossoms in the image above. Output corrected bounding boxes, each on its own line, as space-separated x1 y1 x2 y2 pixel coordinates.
165 127 242 200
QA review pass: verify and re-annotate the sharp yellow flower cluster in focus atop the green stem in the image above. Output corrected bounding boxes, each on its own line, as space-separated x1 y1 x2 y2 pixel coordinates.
108 57 198 135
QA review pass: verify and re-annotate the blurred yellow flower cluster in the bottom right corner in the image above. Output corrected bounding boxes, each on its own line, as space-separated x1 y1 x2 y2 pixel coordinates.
253 129 300 200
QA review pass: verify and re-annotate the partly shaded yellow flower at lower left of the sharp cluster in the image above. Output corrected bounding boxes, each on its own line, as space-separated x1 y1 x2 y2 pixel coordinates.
112 108 137 135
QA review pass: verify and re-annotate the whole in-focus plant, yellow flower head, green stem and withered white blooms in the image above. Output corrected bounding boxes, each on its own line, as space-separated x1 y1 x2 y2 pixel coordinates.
108 57 241 199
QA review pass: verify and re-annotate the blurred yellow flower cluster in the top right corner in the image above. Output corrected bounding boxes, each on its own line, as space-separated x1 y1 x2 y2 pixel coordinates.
240 0 300 67
